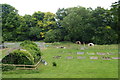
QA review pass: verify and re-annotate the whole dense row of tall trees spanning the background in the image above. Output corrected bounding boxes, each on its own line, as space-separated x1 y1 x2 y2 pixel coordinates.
0 2 120 44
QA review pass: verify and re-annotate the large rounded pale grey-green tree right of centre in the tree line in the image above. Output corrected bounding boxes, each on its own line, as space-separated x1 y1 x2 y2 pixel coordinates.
62 7 93 42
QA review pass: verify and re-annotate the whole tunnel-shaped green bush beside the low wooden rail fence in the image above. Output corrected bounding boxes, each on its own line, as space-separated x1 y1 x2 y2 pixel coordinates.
2 41 41 65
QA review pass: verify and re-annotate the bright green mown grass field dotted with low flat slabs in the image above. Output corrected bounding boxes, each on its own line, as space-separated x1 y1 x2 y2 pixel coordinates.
2 42 118 78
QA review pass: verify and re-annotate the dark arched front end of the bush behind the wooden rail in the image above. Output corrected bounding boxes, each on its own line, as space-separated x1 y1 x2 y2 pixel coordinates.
2 49 34 64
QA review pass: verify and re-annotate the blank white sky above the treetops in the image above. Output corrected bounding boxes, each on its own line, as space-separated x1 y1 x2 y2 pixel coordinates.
0 0 118 15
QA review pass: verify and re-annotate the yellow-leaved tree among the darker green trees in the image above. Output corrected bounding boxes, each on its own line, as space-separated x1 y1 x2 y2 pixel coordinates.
37 12 56 39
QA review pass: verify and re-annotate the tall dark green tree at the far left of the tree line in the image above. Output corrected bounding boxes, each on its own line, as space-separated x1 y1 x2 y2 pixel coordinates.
2 4 20 41
